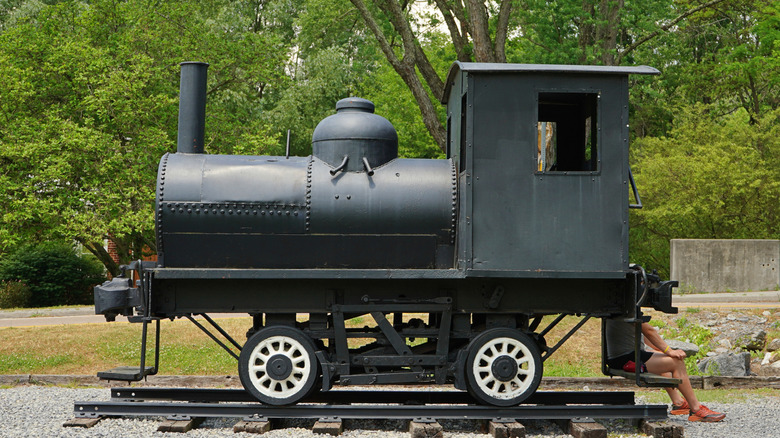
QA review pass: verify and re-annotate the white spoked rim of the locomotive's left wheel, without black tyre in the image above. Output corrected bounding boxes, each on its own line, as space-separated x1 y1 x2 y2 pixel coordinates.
249 336 312 399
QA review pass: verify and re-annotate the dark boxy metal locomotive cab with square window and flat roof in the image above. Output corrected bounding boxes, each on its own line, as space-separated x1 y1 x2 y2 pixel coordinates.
443 62 658 278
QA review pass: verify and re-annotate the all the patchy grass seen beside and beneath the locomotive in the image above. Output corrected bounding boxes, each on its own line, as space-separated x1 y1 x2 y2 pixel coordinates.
0 317 601 377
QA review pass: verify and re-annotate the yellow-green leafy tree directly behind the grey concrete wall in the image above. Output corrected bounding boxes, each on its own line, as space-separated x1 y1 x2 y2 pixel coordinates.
631 104 780 275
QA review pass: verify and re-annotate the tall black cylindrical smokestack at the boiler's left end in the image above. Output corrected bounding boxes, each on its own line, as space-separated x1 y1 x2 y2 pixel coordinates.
176 62 209 154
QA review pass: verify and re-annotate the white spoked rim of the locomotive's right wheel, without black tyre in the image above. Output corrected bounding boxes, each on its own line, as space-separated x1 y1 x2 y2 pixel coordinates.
471 338 536 400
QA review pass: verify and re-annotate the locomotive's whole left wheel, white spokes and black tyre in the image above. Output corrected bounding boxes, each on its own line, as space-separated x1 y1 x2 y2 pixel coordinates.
238 327 318 405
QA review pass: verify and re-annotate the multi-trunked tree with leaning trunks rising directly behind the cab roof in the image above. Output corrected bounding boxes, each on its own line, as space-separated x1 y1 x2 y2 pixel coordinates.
342 0 726 150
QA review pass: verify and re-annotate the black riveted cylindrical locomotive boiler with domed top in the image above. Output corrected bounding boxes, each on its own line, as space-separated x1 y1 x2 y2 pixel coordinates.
156 98 457 269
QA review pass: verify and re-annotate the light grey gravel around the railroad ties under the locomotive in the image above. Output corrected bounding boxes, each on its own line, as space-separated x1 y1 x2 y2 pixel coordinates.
0 386 780 438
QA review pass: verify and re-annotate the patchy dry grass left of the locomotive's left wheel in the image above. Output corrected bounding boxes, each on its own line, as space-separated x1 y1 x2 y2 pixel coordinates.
0 318 251 375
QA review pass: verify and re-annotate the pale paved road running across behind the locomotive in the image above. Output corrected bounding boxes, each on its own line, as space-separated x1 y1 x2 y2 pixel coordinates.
0 291 780 327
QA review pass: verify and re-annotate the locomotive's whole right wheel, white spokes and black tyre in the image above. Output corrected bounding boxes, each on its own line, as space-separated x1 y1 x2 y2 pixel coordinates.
466 328 542 406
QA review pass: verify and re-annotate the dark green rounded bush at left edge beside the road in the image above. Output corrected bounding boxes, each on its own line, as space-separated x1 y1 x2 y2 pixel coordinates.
0 243 106 307
